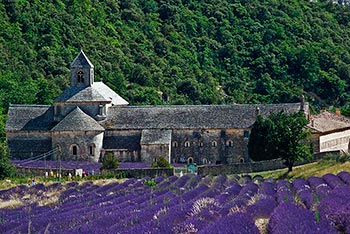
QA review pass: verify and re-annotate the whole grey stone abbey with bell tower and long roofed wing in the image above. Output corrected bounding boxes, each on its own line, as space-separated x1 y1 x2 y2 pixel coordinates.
5 51 309 165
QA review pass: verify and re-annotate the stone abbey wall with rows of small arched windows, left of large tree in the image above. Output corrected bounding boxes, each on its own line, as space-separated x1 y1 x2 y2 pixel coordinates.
171 129 249 165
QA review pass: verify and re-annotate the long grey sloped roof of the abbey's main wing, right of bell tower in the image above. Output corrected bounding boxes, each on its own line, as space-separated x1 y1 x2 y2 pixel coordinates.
101 103 308 129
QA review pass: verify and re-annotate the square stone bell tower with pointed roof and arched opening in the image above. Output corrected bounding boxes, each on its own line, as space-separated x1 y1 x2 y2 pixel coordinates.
70 50 94 87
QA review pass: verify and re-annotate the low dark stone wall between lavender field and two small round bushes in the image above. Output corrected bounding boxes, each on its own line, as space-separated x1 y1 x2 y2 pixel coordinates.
101 168 174 178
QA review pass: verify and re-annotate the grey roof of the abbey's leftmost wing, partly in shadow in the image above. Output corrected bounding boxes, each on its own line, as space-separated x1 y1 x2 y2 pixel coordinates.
5 104 54 131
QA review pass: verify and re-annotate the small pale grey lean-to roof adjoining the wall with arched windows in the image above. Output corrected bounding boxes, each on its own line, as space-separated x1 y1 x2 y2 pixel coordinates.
141 129 172 145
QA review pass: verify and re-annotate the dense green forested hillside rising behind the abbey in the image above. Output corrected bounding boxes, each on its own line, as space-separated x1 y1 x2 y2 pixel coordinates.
0 0 350 133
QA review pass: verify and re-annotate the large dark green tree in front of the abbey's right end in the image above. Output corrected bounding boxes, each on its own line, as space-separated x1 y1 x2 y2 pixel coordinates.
248 112 311 172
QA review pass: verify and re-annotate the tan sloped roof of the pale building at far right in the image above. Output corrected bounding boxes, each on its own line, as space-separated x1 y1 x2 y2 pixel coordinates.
308 111 350 133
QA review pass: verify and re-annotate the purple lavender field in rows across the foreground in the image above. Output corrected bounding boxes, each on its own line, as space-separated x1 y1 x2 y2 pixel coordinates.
0 172 350 234
